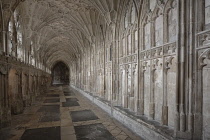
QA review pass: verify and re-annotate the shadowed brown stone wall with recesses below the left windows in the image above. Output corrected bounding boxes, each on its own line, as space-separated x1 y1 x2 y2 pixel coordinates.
0 55 51 128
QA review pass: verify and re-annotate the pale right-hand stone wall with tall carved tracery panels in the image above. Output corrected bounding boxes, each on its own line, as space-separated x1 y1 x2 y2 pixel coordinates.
71 0 210 139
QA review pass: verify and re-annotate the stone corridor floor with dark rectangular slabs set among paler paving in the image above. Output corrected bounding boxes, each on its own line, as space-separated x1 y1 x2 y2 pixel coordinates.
0 86 141 140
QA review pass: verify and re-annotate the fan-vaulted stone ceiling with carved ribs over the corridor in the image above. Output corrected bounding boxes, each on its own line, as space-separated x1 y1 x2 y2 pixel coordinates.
2 0 124 67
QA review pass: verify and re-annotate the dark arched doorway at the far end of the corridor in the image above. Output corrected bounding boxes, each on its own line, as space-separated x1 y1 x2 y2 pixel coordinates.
52 62 69 85
